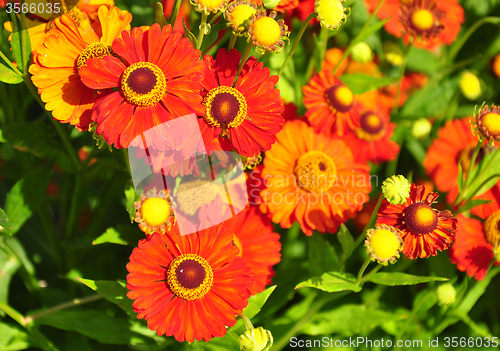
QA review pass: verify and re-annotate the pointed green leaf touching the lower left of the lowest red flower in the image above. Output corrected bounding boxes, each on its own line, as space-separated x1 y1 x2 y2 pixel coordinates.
77 278 136 318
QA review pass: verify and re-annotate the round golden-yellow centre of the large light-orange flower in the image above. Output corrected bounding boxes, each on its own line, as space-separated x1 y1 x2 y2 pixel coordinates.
293 151 337 194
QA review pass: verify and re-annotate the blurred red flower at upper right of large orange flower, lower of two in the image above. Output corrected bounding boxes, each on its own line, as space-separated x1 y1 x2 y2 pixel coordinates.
342 109 399 163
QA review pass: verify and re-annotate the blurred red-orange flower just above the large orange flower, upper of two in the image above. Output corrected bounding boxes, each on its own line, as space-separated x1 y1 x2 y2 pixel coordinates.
302 70 360 136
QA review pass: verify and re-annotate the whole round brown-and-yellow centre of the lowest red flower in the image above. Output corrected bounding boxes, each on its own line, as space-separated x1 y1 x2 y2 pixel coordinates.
166 254 214 300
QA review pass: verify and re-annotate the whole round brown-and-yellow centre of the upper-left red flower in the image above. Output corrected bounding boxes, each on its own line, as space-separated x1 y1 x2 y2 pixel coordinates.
121 62 167 107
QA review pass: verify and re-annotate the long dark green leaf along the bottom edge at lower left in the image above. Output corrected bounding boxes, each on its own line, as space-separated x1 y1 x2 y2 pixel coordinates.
34 310 153 345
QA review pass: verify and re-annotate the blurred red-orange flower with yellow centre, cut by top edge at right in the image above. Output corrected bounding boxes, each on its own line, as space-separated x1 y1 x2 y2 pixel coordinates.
365 0 464 50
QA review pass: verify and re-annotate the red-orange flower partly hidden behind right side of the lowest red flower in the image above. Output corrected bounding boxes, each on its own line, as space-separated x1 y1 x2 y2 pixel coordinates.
227 206 281 295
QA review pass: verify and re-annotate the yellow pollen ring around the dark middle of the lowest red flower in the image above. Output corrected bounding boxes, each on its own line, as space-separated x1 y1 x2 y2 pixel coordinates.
167 254 214 300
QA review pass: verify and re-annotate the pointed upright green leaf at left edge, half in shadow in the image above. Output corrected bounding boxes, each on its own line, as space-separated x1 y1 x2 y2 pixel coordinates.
5 162 52 235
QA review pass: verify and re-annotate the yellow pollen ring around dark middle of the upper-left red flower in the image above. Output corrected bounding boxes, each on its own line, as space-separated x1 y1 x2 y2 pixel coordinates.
120 62 167 107
